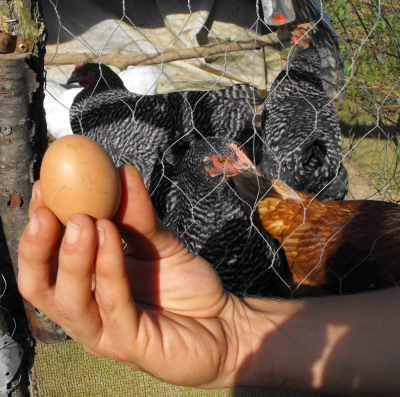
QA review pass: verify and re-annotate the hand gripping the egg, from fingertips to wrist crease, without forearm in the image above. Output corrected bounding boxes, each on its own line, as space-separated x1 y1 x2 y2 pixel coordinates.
18 166 250 387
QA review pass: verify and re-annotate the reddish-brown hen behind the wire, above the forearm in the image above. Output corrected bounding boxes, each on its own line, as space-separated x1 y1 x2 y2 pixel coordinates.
233 172 400 297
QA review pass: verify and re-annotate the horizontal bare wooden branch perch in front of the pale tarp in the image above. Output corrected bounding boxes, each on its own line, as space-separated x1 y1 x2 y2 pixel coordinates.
45 29 291 69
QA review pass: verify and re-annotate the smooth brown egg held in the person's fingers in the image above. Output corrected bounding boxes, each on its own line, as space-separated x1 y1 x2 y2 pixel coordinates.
40 135 121 225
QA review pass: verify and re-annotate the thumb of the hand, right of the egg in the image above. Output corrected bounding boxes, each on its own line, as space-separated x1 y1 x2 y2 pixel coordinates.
115 165 182 257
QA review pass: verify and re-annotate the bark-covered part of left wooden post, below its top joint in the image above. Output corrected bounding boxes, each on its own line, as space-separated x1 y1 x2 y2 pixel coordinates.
0 54 66 343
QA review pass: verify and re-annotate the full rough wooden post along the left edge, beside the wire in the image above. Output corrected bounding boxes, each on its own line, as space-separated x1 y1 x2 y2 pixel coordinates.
0 0 66 343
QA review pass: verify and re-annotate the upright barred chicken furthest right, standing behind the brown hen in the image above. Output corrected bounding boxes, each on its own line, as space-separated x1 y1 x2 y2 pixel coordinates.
259 30 348 200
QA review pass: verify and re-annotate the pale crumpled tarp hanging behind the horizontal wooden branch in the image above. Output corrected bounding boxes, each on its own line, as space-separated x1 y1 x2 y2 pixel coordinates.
43 0 290 92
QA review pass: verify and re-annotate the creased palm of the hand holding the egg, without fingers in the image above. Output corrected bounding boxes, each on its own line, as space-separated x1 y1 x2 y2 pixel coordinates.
123 241 233 386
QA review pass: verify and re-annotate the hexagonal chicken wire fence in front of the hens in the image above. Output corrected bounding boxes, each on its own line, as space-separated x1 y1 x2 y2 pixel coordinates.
36 0 400 296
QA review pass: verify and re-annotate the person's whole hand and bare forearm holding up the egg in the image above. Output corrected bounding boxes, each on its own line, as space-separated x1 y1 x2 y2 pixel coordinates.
18 166 400 396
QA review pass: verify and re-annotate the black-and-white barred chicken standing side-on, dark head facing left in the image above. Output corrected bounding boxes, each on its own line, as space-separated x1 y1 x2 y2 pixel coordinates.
69 63 261 186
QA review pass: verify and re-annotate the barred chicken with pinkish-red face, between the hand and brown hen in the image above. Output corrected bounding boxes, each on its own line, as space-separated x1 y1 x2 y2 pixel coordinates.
159 138 283 296
